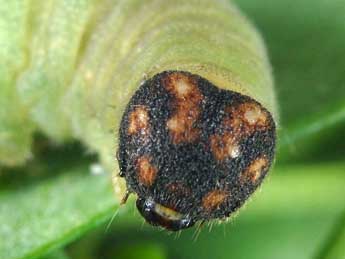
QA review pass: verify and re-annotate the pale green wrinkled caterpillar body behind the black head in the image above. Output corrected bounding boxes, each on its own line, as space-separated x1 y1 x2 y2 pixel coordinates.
0 0 277 177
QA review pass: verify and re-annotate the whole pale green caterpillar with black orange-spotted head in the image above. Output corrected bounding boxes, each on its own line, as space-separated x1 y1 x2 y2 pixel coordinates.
0 0 278 231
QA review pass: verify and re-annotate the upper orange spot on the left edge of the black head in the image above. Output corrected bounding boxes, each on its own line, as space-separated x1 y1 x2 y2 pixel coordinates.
128 106 150 135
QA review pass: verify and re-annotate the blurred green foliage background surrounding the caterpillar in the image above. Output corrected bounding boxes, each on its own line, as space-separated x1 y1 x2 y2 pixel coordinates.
0 0 345 259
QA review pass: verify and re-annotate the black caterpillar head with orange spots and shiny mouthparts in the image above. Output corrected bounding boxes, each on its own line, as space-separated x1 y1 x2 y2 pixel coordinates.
119 71 276 231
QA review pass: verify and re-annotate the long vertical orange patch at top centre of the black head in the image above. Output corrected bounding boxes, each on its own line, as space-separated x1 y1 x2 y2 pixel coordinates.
162 72 203 144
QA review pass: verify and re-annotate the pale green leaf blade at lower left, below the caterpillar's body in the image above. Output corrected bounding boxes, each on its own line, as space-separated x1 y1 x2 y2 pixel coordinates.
0 146 117 259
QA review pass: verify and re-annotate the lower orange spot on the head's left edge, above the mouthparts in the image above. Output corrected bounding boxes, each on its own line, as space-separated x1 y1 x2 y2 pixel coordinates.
136 156 158 187
